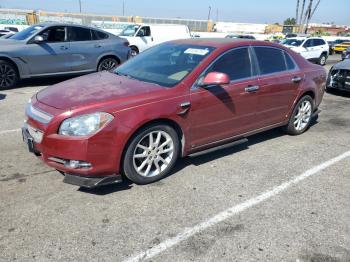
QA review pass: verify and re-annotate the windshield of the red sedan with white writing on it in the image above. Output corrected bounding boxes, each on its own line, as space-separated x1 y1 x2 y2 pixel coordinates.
115 43 215 87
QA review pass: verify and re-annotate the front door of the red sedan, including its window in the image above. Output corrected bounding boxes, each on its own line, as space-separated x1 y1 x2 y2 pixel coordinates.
189 47 258 148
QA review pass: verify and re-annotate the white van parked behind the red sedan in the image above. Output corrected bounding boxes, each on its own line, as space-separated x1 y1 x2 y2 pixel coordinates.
119 24 191 56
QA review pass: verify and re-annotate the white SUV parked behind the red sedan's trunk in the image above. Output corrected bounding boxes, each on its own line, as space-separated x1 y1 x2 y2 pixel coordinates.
282 37 329 65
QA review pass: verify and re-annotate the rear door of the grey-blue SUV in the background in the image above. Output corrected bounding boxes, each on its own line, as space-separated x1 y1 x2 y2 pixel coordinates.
68 26 105 71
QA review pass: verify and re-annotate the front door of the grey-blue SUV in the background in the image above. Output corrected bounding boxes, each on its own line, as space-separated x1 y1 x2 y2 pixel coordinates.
22 26 71 75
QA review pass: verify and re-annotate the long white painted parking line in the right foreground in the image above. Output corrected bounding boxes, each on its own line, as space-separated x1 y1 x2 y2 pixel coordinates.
125 151 350 262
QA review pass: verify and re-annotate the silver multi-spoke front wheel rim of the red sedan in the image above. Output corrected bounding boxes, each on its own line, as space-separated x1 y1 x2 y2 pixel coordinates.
133 131 174 177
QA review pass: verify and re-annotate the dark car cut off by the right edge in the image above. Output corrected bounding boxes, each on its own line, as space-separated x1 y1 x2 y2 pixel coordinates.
327 57 350 92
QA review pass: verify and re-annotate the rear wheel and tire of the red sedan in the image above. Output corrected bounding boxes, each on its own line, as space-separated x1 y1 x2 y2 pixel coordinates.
285 95 314 136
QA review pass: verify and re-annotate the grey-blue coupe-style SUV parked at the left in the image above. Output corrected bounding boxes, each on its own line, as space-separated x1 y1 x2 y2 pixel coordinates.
0 24 130 88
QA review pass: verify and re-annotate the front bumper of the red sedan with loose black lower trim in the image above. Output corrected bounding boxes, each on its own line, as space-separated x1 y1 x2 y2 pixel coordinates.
22 121 122 188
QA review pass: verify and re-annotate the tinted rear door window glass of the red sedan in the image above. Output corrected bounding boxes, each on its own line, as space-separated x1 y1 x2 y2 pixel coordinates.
254 47 287 75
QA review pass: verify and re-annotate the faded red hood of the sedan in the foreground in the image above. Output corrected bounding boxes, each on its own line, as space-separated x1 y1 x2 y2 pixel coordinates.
36 72 167 110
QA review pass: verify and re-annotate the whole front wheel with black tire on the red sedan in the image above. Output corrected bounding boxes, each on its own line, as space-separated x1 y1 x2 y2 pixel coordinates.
123 124 180 185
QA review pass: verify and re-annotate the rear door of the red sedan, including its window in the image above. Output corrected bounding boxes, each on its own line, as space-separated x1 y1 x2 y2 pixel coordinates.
253 46 303 128
